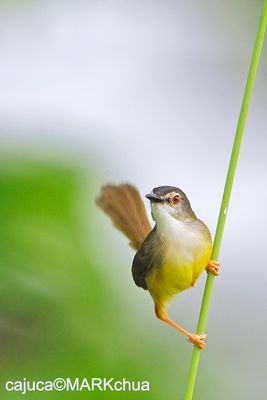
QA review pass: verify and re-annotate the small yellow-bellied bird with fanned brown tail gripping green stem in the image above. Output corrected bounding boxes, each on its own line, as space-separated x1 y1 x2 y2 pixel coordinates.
96 183 220 349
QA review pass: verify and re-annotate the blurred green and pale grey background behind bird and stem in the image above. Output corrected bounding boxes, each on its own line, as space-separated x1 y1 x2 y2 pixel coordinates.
0 0 267 400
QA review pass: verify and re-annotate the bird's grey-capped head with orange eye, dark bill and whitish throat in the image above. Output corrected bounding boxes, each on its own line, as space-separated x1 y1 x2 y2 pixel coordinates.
146 186 196 223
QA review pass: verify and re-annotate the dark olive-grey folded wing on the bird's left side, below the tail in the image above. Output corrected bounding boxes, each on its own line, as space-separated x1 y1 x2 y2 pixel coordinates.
132 227 161 290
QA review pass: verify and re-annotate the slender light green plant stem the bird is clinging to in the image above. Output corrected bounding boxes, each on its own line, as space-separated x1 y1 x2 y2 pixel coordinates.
184 0 267 400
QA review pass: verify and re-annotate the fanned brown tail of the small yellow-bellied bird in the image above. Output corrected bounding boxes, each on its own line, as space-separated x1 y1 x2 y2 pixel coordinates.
96 183 152 249
